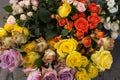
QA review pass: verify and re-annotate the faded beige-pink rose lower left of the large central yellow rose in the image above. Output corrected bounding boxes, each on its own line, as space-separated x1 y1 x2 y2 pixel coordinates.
42 49 56 64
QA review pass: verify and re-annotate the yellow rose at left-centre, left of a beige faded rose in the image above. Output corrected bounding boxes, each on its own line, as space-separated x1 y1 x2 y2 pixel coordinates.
22 41 36 53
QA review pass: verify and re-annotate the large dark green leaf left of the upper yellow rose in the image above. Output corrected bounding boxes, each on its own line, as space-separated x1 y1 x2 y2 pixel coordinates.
39 8 51 23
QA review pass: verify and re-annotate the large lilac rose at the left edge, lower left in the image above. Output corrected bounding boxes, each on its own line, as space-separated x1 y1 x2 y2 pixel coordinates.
0 49 23 72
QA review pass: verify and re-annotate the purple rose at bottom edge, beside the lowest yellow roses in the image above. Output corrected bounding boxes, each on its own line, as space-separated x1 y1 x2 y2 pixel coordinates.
58 67 73 80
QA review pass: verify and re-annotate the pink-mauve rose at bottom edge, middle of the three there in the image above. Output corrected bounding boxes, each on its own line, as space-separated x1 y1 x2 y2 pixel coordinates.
42 67 58 80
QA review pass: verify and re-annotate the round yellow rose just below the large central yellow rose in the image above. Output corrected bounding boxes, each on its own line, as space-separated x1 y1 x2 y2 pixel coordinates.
66 51 82 68
